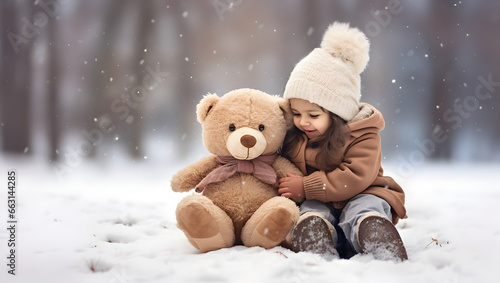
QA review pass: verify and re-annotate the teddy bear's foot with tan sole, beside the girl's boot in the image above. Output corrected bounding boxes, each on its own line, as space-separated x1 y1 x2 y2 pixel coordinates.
242 203 295 249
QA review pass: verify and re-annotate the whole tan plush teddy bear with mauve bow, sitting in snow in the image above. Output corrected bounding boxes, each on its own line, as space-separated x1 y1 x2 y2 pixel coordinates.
171 89 302 252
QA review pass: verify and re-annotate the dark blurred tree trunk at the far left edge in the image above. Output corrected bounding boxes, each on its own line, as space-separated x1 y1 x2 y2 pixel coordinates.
0 1 32 153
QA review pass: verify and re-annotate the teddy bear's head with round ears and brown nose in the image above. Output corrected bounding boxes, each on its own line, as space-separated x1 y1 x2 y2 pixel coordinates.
196 89 292 160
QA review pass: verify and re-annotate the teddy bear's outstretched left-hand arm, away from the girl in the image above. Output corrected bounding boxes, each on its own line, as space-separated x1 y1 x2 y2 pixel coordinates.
170 155 217 192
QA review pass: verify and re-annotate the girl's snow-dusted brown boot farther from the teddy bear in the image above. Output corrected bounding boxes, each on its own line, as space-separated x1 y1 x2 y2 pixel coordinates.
356 213 408 261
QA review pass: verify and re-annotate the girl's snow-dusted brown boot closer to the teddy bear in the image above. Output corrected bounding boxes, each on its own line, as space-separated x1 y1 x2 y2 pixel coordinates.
291 212 338 254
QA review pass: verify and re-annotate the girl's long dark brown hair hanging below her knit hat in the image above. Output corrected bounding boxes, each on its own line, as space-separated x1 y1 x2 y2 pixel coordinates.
282 107 350 172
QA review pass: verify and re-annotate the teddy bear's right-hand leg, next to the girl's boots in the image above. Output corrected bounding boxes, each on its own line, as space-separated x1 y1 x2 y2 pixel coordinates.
241 197 300 249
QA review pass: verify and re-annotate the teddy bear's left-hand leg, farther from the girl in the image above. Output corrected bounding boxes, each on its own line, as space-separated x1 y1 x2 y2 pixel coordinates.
176 195 235 252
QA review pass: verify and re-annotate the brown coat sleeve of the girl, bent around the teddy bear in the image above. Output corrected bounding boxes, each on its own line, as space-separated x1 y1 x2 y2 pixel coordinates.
304 133 382 202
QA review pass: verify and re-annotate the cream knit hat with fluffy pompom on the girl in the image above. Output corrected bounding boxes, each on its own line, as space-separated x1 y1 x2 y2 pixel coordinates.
284 22 370 121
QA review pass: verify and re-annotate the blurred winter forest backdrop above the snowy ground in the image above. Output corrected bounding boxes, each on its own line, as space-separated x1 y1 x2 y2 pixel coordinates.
0 0 500 176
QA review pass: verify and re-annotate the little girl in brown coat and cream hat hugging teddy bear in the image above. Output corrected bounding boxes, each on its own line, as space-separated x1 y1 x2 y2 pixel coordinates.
278 23 408 260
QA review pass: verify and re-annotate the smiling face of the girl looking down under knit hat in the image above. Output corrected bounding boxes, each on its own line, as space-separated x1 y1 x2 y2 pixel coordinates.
290 98 331 138
